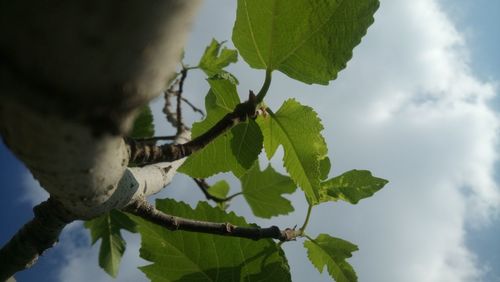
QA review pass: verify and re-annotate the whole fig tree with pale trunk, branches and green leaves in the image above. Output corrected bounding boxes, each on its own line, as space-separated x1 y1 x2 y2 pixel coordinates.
0 0 387 281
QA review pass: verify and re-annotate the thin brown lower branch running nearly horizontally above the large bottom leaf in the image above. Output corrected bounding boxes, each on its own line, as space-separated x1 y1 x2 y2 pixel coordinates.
124 199 300 241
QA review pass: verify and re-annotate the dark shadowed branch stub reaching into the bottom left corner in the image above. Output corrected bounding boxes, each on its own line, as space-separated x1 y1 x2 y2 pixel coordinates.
0 198 76 281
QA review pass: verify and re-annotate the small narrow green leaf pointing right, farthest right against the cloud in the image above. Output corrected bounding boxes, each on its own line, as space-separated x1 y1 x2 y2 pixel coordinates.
320 170 389 204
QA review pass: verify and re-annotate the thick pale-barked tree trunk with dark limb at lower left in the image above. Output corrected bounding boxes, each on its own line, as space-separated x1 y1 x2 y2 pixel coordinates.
0 0 200 280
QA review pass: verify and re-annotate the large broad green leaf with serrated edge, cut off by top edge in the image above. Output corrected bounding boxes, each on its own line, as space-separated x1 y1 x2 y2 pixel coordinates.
232 0 379 84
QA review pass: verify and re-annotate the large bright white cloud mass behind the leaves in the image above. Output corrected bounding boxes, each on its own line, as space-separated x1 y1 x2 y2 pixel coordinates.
50 0 500 282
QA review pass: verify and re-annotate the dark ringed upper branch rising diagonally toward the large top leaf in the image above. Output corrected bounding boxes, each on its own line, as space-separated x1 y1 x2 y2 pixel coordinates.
126 91 257 165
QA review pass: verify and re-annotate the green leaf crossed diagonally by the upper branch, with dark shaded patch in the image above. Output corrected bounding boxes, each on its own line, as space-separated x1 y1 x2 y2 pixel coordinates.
179 78 263 178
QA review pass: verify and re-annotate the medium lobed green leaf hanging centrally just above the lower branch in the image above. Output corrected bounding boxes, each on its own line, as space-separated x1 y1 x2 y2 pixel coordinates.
241 161 297 218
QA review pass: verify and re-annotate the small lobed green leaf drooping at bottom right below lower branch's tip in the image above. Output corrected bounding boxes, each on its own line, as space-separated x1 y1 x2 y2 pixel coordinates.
304 234 358 282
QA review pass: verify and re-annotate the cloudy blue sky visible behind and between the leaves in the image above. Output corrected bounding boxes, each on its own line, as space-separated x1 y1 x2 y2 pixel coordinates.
0 0 500 282
